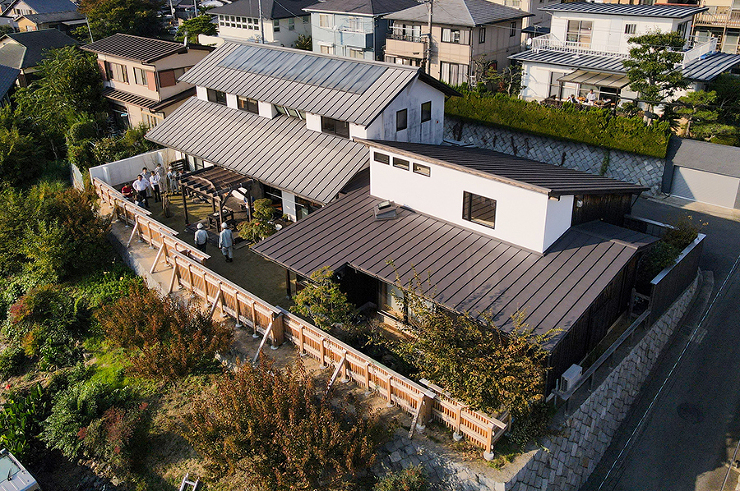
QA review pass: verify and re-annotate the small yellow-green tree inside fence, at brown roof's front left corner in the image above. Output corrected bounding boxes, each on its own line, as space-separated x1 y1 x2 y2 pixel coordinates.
291 266 355 331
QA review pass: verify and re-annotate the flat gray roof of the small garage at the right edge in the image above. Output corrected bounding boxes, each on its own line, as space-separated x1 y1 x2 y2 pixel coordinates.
666 137 740 177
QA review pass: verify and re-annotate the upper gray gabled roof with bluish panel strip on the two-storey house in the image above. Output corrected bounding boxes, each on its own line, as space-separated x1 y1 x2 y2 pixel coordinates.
180 41 457 126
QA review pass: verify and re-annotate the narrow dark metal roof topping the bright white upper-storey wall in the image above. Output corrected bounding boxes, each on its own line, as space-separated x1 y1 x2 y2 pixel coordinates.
367 141 649 196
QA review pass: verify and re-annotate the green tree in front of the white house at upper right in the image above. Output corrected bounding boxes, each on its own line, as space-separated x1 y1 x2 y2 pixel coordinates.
622 31 689 118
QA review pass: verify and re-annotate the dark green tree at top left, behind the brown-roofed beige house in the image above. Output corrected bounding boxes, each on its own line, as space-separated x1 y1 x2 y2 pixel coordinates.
76 0 163 40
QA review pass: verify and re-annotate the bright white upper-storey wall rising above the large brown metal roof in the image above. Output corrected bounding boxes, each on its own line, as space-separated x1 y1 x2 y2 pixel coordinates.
370 149 572 252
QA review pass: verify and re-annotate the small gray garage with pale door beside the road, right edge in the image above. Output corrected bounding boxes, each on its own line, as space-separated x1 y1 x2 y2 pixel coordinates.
663 137 740 209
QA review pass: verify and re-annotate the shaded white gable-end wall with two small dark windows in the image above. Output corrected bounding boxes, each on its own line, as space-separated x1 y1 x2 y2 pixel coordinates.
367 79 444 145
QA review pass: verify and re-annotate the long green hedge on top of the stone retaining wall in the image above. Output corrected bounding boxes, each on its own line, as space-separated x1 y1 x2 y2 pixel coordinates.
445 93 670 158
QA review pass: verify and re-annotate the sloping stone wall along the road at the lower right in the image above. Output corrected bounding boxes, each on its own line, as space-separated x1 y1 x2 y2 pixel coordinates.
506 276 698 491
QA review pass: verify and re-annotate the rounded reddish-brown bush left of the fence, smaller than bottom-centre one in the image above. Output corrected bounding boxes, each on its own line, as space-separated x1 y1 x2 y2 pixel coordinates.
96 287 233 380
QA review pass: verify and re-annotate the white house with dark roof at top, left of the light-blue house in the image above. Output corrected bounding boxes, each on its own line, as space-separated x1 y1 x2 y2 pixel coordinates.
208 0 316 47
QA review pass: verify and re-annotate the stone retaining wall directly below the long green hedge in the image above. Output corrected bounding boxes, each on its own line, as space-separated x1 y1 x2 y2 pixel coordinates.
445 116 665 196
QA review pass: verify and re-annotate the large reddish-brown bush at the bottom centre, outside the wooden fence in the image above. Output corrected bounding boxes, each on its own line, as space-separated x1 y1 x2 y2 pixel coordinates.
179 357 388 491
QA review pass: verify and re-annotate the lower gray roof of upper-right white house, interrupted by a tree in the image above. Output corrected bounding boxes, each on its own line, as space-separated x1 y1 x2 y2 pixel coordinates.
509 49 740 82
